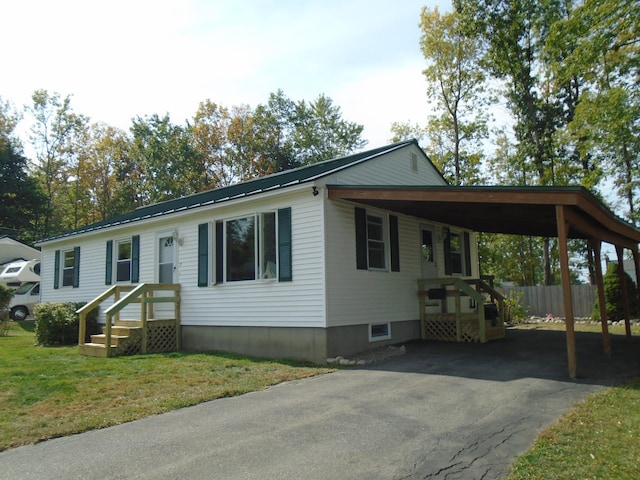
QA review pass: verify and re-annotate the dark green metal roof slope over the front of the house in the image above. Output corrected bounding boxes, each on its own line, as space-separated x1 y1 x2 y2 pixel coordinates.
40 140 418 243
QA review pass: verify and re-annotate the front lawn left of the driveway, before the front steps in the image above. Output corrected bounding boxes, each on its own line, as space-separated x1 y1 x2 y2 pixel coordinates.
0 321 332 451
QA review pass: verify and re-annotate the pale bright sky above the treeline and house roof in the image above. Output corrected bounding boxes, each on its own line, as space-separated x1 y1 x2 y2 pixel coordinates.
0 0 451 148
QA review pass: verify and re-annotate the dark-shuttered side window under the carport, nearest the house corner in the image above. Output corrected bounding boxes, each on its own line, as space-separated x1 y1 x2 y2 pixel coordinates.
355 208 400 272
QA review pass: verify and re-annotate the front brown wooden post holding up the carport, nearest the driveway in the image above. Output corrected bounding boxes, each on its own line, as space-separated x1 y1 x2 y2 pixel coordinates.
556 205 578 378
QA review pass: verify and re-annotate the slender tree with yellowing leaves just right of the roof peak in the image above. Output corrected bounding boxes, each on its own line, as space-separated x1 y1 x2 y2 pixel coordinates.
420 7 488 185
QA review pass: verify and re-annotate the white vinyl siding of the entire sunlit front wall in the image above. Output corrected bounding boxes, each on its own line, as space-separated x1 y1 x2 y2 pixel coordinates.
42 188 325 327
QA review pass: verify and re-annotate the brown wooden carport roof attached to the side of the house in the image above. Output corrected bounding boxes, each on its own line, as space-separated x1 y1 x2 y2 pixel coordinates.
328 185 640 250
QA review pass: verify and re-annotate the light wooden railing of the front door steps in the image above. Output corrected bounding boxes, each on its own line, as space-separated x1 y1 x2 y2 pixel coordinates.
77 283 181 357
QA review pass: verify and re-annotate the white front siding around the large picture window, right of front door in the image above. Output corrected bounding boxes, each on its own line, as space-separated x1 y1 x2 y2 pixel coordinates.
180 189 325 327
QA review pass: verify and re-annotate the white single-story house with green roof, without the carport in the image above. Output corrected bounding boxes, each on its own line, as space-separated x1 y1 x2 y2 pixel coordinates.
39 141 488 362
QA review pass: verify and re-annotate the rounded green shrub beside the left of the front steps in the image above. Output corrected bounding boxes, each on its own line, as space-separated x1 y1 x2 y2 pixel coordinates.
33 302 100 345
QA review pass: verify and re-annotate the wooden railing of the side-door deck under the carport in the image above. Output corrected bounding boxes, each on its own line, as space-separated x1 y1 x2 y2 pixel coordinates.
418 277 505 342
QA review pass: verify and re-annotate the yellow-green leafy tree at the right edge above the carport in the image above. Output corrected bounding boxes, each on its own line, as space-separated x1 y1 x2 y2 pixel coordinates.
547 0 640 222
